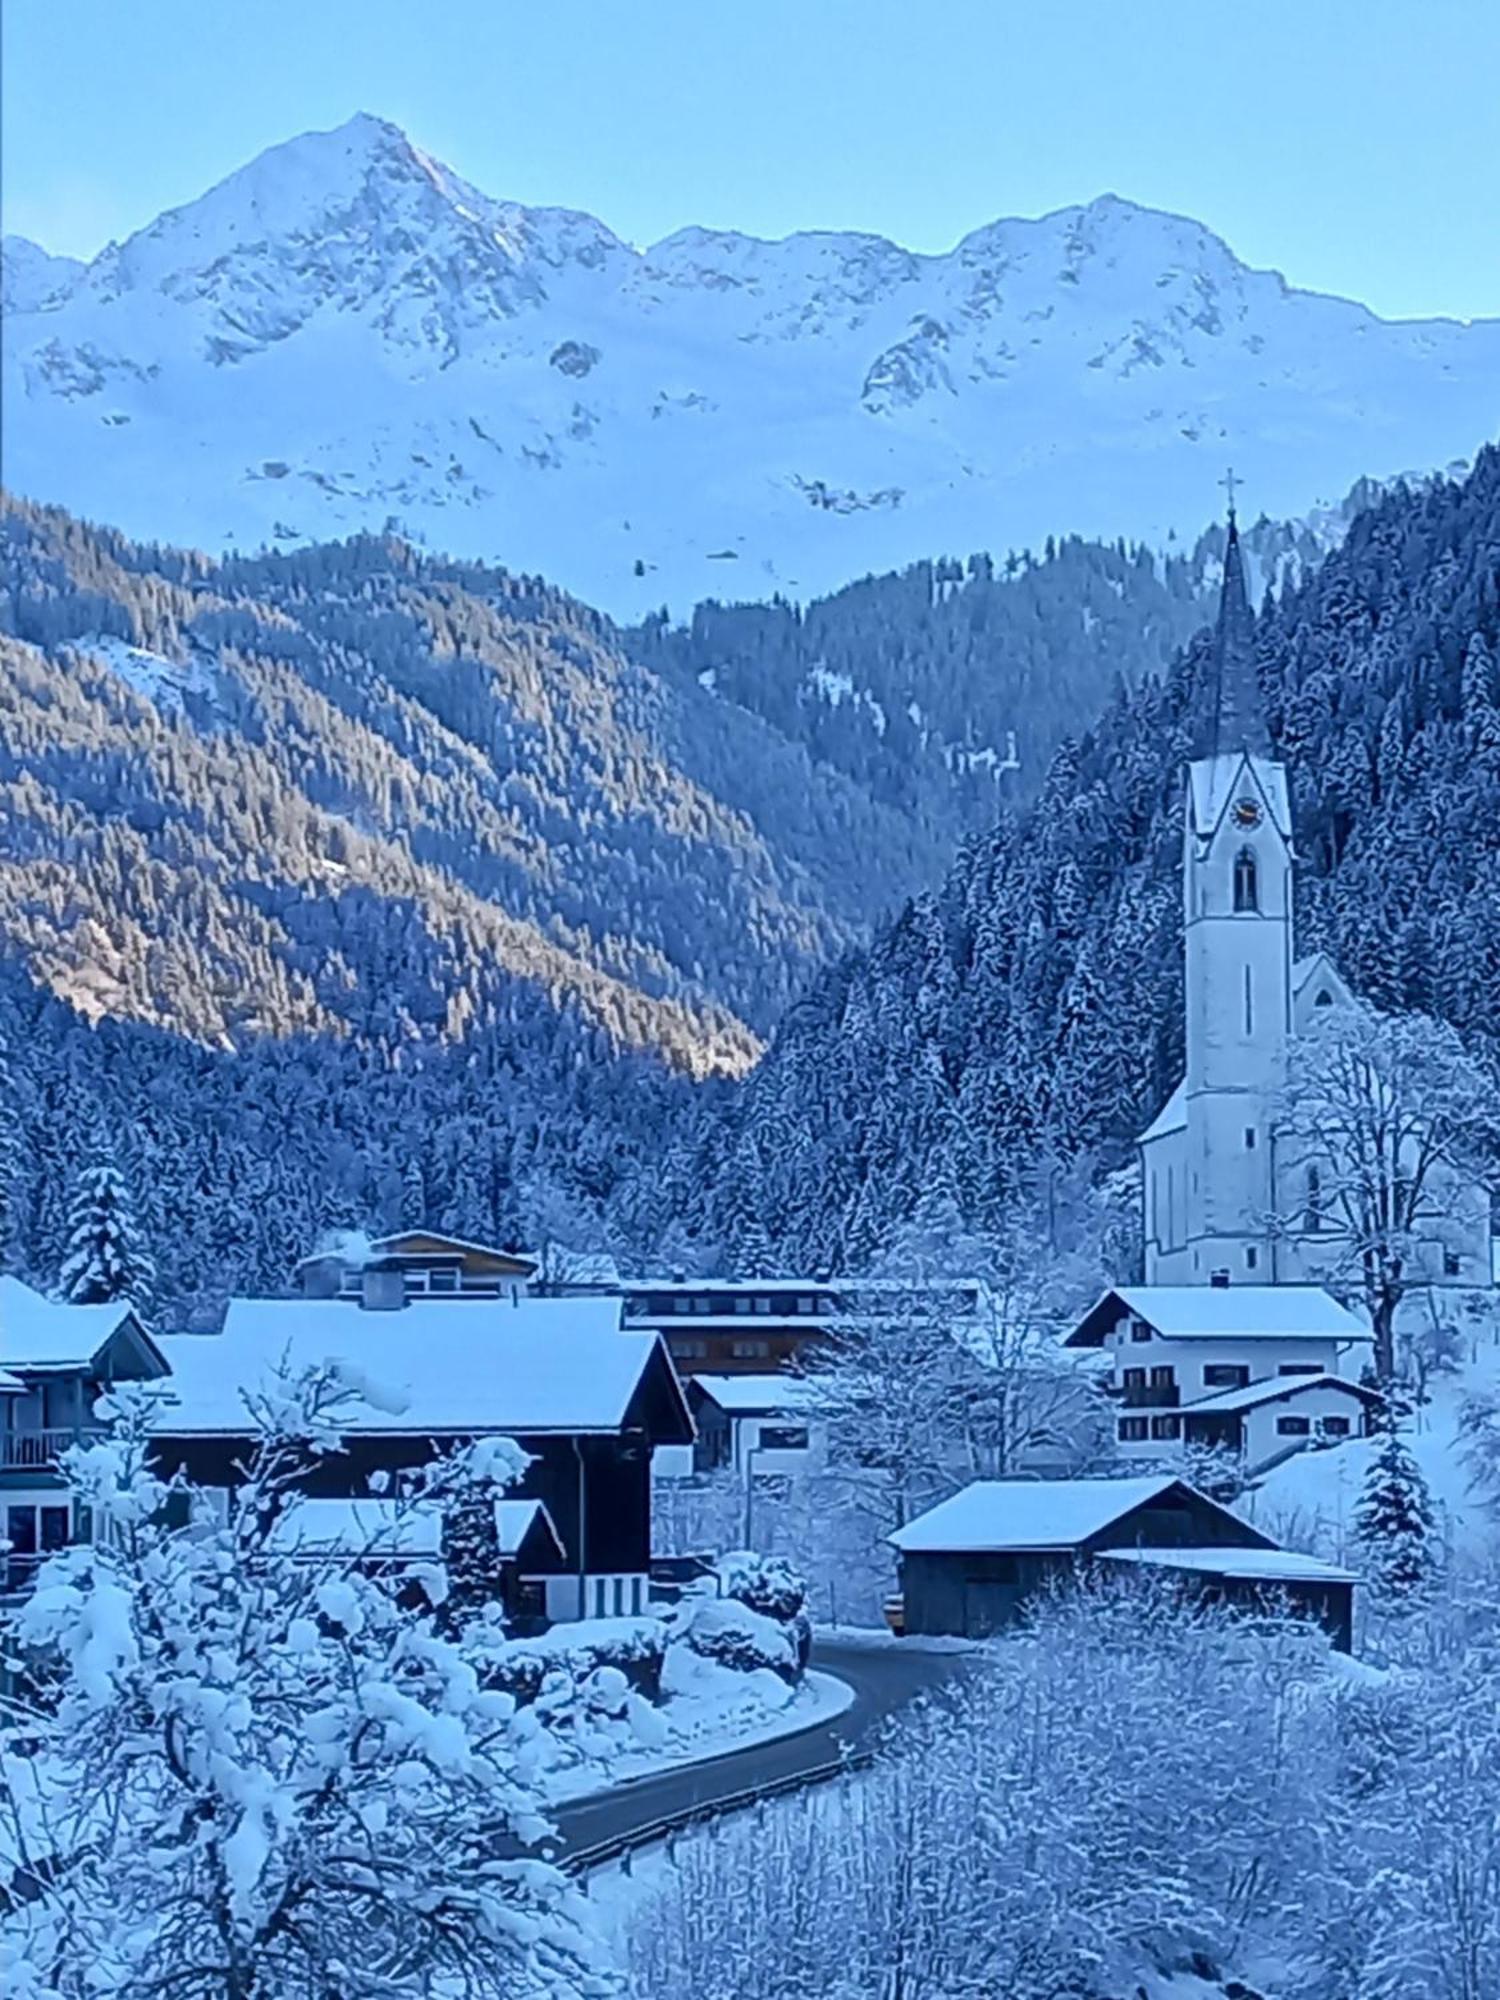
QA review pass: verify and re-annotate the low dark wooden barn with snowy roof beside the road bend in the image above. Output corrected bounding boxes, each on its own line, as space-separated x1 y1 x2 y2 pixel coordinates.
890 1476 1356 1652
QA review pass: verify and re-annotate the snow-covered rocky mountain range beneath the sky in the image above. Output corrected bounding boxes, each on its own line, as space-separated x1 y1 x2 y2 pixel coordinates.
4 116 1500 616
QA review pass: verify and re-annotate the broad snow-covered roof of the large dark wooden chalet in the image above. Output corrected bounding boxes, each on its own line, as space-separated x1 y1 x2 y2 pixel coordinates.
158 1298 692 1442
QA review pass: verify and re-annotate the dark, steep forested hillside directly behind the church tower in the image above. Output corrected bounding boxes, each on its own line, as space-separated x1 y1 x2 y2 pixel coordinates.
676 448 1500 1266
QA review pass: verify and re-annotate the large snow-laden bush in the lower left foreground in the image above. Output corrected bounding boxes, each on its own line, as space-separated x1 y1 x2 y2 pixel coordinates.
0 1372 618 2000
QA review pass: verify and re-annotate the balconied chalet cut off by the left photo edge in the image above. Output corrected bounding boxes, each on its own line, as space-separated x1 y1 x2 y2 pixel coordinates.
0 1278 168 1594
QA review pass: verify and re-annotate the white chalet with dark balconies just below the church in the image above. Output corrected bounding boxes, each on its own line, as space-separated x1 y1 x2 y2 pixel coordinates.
1064 1284 1378 1472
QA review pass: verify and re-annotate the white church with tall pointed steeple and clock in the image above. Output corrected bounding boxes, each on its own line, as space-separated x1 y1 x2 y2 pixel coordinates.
1138 508 1492 1286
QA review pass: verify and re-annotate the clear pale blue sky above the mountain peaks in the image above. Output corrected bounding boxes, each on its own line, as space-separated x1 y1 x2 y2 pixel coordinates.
0 0 1500 318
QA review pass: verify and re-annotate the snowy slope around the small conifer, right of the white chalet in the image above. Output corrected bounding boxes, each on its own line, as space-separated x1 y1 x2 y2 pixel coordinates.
1238 1300 1500 1568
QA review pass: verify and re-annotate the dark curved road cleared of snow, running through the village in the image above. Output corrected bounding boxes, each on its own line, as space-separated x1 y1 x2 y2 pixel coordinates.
554 1636 966 1858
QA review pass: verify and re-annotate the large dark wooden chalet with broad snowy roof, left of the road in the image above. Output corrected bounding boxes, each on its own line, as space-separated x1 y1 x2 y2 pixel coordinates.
156 1290 692 1618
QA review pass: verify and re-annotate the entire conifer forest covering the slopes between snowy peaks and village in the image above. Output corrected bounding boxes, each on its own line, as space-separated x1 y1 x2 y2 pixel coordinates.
0 450 1500 1324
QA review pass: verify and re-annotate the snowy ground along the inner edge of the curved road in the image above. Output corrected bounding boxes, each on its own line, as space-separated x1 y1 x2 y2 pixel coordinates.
546 1646 854 1804
